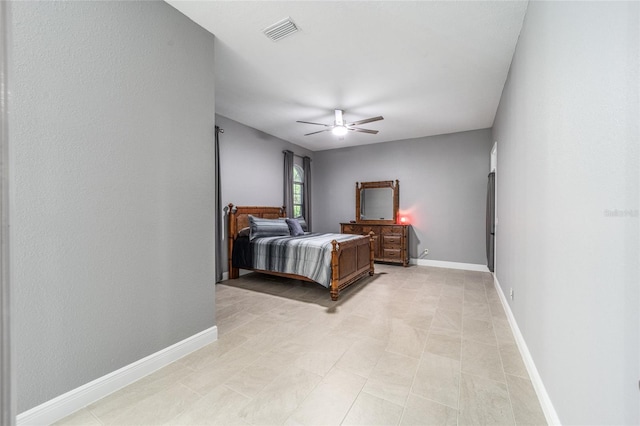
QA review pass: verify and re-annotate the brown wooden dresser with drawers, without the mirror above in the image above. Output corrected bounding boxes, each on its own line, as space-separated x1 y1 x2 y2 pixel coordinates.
340 223 411 266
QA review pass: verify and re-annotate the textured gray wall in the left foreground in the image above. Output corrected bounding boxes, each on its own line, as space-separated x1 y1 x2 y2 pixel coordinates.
9 2 215 412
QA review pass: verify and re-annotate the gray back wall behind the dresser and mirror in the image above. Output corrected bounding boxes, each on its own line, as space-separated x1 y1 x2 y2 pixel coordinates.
313 129 492 264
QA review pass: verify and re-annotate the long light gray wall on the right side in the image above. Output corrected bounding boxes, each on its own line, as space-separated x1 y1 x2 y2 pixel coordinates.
493 1 640 425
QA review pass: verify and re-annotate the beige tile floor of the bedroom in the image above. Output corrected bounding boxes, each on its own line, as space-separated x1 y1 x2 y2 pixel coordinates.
59 264 546 425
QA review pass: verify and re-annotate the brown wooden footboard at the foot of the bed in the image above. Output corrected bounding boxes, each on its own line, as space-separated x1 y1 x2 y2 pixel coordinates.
330 232 374 300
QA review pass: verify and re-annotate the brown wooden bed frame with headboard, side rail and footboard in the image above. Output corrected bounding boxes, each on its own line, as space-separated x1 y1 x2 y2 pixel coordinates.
228 204 374 300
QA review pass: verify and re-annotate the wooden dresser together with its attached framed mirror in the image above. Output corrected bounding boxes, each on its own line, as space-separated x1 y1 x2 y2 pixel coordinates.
340 180 411 266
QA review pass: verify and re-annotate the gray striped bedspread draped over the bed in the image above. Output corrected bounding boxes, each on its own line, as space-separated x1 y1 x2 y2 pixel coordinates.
252 234 362 287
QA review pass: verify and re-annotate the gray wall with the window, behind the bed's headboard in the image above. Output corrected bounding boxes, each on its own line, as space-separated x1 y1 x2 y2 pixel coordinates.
216 115 318 271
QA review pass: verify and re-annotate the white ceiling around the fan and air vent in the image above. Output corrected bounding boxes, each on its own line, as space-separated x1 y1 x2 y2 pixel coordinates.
166 0 527 151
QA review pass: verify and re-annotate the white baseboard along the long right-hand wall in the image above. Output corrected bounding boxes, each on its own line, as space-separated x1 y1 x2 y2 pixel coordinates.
493 274 561 425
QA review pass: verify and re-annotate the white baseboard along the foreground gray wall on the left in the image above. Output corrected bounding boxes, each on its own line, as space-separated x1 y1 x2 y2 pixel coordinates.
17 326 218 426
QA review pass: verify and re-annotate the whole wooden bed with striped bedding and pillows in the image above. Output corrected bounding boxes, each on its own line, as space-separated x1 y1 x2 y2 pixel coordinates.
228 204 374 300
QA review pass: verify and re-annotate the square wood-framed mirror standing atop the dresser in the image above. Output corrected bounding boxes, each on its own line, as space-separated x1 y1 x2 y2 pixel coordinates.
356 180 400 224
